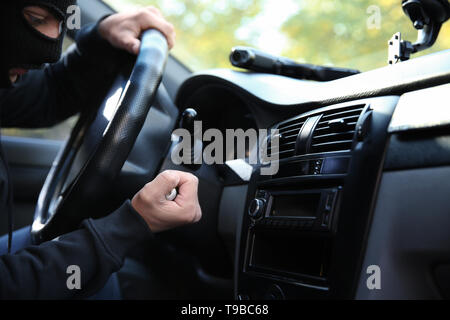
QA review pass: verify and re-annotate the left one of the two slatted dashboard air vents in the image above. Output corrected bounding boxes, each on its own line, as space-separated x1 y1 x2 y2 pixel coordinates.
269 118 306 160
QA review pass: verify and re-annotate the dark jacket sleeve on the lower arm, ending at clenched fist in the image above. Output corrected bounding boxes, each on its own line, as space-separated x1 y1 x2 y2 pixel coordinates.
0 201 153 299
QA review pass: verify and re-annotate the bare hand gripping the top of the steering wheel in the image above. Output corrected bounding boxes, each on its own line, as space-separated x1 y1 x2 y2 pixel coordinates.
99 7 175 55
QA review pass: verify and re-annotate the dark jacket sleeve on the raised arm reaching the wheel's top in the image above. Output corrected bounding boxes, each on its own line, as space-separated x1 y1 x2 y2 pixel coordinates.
0 23 129 128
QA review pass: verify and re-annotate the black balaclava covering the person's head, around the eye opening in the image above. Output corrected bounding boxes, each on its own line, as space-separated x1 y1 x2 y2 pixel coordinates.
0 0 76 88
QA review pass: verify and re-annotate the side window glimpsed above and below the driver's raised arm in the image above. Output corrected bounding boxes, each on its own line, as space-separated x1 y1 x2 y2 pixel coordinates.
1 37 78 140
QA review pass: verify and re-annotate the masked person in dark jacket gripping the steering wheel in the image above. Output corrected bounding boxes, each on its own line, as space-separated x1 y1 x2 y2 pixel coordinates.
0 0 201 299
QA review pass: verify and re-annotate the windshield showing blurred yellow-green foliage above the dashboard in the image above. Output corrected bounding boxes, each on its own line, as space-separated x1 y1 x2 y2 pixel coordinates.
105 0 450 71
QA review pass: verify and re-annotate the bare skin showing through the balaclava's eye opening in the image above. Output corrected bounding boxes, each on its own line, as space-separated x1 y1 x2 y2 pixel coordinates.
22 6 64 39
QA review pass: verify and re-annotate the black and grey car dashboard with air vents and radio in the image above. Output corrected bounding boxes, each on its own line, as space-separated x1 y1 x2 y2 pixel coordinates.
166 51 450 300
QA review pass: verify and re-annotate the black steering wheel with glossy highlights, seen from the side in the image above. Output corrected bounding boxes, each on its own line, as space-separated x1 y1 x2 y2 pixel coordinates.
31 30 169 244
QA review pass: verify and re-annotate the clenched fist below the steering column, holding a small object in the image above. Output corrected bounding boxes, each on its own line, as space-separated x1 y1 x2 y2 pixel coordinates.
131 170 202 233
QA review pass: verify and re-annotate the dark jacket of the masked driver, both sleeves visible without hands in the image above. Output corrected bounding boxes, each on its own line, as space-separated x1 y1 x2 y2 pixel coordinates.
0 25 152 299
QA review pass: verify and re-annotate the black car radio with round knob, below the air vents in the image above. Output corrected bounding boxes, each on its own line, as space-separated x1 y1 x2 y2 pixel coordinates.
249 187 341 232
